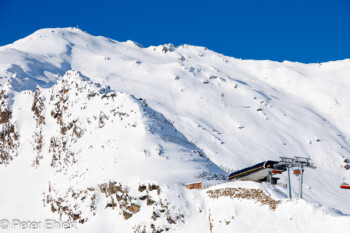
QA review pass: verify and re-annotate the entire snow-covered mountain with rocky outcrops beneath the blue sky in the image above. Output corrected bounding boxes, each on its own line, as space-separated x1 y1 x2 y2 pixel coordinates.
0 28 350 232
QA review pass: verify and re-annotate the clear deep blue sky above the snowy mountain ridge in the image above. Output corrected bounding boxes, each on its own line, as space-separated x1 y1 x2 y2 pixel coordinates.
0 0 350 63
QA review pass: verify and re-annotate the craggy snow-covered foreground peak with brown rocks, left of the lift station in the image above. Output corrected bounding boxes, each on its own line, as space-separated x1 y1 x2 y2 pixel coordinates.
0 71 226 233
